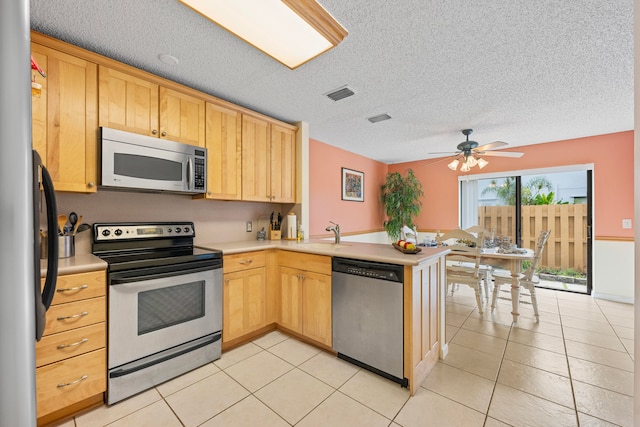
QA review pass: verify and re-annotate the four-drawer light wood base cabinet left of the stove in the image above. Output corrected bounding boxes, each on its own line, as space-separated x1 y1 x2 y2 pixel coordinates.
36 271 107 424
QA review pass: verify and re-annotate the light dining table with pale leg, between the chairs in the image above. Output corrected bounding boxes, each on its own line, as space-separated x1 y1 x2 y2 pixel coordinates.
480 247 534 323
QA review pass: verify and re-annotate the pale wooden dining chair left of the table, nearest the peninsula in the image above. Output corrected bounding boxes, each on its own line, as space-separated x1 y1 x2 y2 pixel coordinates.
436 229 483 314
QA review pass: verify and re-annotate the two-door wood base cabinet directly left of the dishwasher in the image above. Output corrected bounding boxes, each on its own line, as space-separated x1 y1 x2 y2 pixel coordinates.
278 251 332 347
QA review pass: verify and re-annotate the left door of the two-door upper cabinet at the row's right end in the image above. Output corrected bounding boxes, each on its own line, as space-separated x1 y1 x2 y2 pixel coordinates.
242 115 271 202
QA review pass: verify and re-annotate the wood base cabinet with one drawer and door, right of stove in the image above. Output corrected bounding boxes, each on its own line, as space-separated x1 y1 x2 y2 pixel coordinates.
222 252 267 343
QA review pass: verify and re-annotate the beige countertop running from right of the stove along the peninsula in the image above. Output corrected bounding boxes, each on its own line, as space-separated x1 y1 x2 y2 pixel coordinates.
196 240 449 265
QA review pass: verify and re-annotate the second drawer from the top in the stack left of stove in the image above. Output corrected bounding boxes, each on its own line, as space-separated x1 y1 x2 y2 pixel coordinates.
44 297 106 335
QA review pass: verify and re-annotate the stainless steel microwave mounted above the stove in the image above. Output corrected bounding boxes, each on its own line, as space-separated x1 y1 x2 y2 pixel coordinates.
100 127 207 194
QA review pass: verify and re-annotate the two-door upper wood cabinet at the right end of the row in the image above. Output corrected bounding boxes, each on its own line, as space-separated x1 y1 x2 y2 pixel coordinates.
242 115 296 203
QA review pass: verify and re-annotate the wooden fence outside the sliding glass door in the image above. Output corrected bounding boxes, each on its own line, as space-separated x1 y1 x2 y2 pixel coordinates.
478 204 587 272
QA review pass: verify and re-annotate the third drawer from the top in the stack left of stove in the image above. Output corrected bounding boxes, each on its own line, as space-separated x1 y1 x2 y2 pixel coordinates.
36 323 106 367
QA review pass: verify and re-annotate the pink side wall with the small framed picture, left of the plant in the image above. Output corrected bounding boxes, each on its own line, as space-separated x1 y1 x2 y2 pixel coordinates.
303 139 387 237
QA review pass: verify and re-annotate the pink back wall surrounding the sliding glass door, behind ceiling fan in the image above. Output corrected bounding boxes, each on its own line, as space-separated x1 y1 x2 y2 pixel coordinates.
390 131 635 239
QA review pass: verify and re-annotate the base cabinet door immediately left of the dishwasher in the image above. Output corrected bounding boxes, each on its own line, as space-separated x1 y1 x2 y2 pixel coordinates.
302 271 331 347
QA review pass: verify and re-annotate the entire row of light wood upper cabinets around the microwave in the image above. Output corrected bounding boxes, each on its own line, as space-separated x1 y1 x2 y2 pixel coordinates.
31 32 299 203
